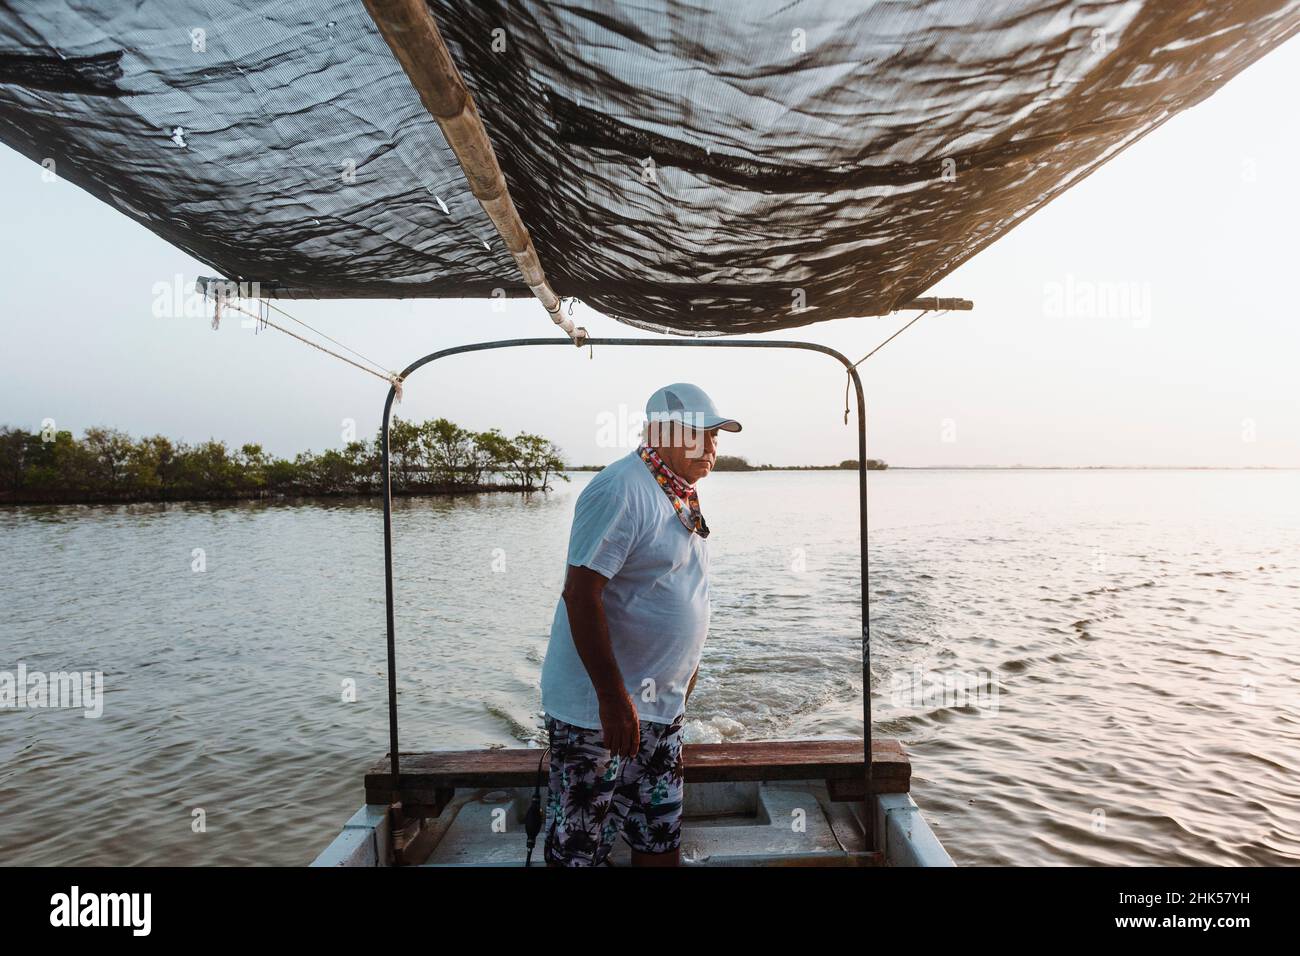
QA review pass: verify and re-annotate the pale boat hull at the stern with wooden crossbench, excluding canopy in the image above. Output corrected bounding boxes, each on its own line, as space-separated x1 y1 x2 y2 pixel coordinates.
312 740 953 868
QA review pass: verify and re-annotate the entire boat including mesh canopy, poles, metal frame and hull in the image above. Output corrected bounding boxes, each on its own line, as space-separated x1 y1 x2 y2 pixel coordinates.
0 0 1300 866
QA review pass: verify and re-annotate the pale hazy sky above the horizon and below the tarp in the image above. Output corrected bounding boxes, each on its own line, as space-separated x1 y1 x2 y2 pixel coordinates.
0 34 1300 467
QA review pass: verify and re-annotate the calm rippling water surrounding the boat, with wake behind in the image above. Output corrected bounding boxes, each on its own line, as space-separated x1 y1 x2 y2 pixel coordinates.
0 471 1300 865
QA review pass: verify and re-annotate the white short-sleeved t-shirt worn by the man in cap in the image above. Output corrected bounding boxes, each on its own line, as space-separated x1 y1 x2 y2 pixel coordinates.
542 450 709 728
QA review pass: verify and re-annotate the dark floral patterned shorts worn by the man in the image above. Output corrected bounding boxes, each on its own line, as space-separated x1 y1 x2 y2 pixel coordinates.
546 714 685 866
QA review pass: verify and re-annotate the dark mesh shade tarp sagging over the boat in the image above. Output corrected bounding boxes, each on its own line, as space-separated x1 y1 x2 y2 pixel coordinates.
0 0 1300 334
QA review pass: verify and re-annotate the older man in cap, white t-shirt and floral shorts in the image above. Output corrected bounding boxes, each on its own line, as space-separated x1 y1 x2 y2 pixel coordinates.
542 382 741 866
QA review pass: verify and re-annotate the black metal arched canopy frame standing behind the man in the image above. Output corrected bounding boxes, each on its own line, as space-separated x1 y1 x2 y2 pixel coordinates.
381 338 876 849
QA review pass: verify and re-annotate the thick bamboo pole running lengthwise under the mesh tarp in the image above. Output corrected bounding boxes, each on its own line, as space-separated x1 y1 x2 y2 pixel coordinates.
365 0 586 345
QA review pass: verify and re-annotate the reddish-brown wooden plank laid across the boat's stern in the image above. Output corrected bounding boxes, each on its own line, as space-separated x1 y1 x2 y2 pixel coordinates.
365 739 911 804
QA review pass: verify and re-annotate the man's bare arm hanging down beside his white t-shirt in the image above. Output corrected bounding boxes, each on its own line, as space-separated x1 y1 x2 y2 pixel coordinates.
564 564 641 757
